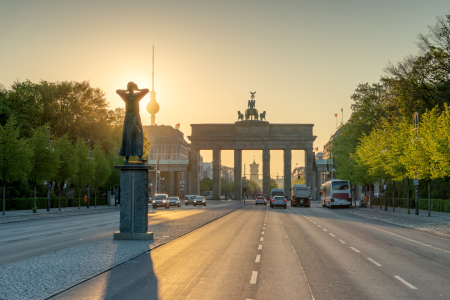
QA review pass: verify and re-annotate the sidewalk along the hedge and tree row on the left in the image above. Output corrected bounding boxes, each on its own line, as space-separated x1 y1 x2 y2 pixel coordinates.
0 205 120 223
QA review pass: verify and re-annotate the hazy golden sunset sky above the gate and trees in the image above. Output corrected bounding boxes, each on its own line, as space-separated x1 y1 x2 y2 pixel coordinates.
0 0 450 178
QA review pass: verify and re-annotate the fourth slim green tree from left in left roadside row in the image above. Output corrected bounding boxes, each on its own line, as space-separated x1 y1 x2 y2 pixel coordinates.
75 138 95 208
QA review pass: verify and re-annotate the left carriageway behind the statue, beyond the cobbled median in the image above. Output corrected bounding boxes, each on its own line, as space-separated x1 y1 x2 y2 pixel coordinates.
0 201 231 266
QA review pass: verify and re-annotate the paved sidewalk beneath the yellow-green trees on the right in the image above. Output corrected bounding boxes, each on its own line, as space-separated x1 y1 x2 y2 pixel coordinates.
349 206 450 237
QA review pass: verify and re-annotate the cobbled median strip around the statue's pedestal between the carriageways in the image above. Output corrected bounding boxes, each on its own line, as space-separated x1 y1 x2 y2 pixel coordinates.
0 204 242 300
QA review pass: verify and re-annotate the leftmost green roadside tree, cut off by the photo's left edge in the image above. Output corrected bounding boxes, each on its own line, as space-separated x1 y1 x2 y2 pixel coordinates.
0 117 31 214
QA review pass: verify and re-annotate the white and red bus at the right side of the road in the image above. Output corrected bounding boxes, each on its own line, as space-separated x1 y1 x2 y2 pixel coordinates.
320 179 352 208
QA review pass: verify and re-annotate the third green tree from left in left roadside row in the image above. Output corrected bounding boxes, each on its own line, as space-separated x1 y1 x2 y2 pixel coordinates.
54 133 79 210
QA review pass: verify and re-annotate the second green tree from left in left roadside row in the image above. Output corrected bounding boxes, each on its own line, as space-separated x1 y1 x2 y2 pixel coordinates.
28 124 59 211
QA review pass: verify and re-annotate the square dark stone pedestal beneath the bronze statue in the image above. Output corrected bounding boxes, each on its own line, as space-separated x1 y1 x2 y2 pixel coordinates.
114 162 153 240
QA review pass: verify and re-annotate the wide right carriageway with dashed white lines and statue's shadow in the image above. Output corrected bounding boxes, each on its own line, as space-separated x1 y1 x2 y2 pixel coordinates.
50 204 450 299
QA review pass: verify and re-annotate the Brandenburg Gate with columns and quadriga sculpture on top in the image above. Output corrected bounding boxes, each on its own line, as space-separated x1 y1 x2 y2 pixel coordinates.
188 93 316 199
